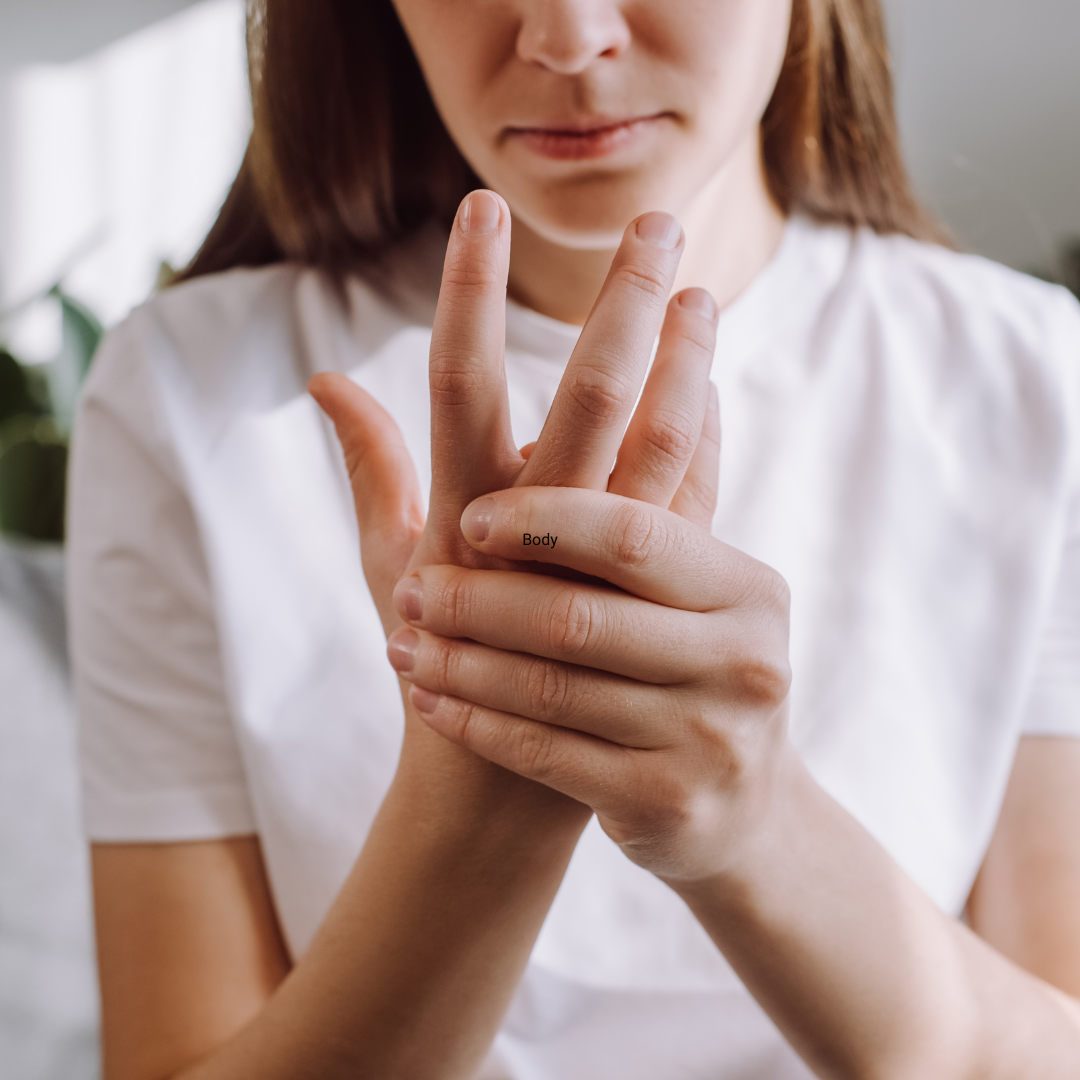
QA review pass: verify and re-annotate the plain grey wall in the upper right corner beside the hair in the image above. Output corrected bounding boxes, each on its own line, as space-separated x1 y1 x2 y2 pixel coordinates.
885 0 1080 271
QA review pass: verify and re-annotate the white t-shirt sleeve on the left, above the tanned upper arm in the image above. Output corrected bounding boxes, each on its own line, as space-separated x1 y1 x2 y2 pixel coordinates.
68 314 255 842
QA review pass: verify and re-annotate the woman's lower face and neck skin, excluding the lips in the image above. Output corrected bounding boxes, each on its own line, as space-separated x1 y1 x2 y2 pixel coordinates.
395 0 791 324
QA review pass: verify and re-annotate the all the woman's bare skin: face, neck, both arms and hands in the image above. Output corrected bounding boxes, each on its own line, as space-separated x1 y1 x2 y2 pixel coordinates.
94 0 1080 1080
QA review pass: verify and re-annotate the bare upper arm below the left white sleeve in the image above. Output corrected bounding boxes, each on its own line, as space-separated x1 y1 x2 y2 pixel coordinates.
93 837 289 1080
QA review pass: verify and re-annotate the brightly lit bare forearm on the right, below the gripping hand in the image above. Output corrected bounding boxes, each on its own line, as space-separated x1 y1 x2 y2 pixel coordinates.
672 754 1080 1080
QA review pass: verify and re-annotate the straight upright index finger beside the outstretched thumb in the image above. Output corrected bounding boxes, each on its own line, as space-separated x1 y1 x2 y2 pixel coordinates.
429 191 521 525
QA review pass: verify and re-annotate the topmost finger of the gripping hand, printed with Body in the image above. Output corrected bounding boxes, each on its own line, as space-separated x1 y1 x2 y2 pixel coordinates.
461 487 760 611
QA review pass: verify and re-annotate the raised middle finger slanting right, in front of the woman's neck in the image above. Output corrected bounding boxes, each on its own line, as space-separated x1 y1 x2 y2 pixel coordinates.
518 213 684 490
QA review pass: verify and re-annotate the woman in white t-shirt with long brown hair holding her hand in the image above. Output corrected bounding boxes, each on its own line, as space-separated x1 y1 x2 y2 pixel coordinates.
71 0 1080 1080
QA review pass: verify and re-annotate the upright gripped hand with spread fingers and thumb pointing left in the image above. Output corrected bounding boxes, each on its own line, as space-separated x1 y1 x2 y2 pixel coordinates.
310 191 719 794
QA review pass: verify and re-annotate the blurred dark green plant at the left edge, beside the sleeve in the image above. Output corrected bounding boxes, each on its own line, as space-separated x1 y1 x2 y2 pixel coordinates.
0 286 102 542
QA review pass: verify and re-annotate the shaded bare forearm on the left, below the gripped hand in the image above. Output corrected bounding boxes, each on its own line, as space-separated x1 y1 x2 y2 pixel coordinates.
183 717 588 1080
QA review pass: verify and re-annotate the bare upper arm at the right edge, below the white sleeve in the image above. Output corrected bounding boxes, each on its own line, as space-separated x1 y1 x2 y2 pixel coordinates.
968 735 1080 997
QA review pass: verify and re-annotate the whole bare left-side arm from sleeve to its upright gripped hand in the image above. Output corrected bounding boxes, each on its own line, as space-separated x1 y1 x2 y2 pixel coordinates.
93 192 719 1080
